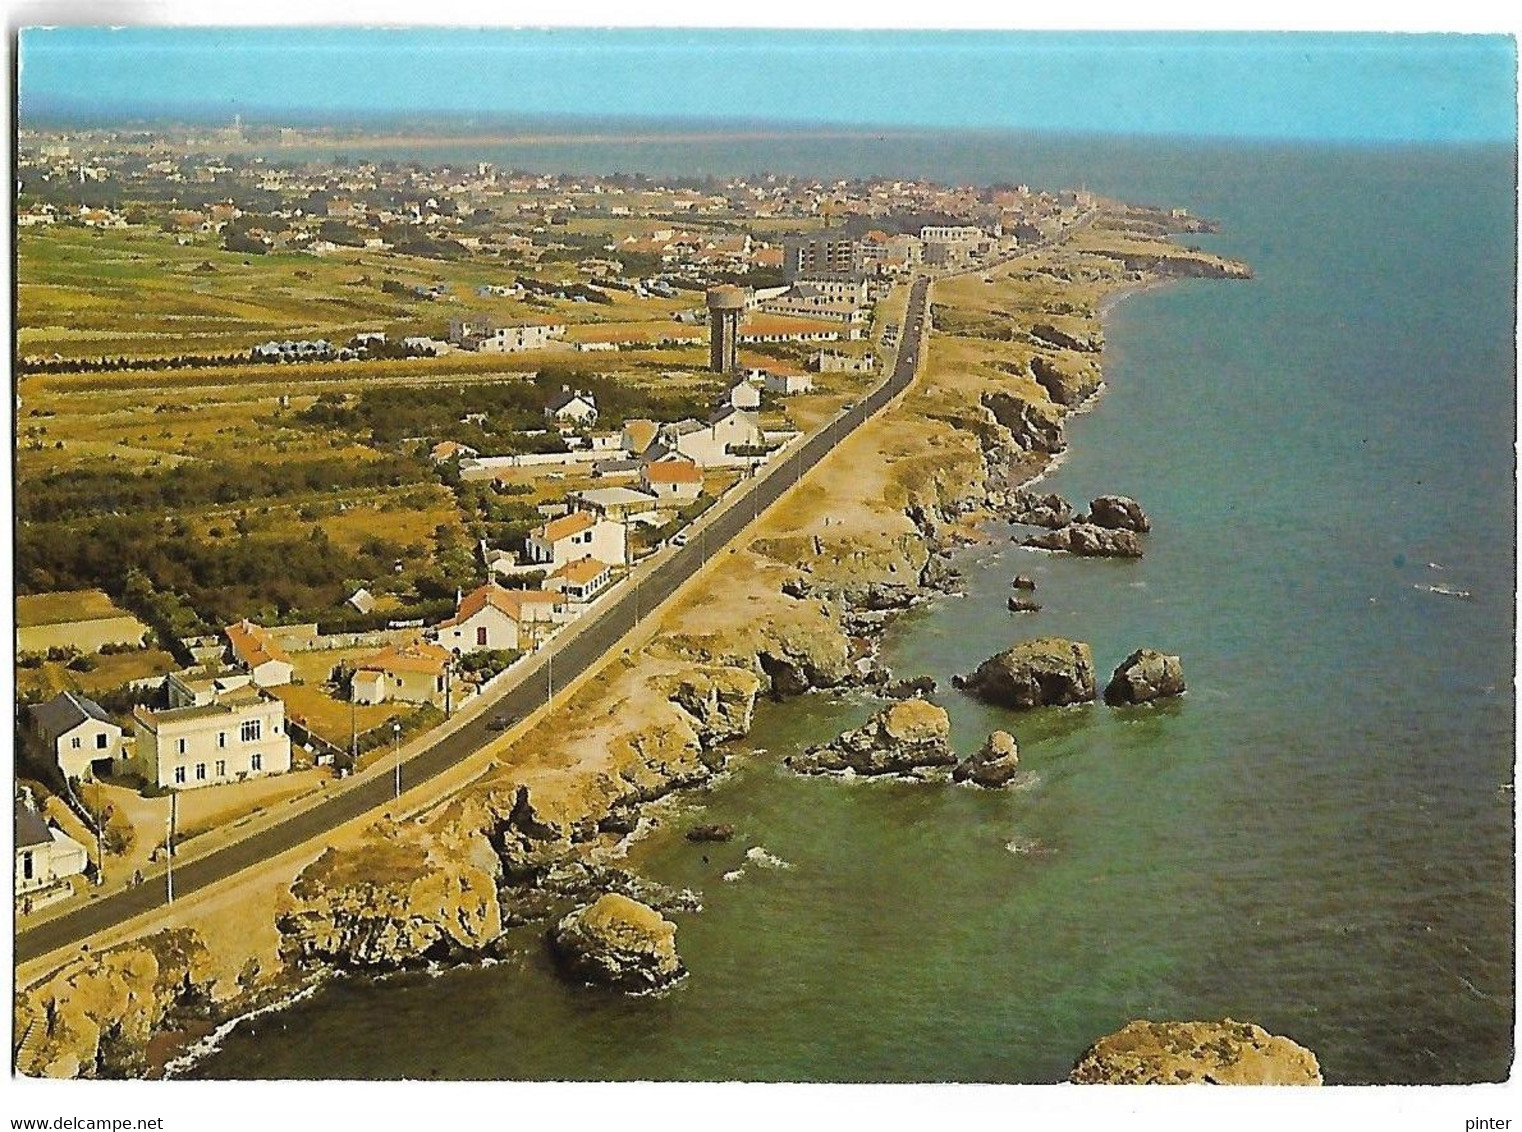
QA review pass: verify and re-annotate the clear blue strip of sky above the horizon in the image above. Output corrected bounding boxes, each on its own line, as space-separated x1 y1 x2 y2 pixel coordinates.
20 27 1516 142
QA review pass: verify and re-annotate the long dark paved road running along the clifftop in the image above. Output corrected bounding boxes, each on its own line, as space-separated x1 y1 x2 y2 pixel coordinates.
15 277 930 963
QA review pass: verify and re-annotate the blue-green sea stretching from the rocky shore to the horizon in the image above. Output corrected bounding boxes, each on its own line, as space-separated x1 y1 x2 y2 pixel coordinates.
193 134 1516 1082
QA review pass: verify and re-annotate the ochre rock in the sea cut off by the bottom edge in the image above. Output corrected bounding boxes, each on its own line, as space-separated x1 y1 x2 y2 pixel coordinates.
1068 1018 1321 1085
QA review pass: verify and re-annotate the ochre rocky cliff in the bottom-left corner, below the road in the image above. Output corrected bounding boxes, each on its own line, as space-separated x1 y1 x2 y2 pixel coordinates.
15 928 216 1077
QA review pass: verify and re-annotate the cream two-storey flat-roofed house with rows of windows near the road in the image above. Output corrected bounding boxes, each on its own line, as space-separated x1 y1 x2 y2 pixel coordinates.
132 688 291 790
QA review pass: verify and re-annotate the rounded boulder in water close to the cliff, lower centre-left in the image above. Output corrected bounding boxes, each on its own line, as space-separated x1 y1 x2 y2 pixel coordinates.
549 892 686 994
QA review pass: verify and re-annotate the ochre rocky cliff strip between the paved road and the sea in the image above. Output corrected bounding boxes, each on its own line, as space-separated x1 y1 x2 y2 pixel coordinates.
14 202 1250 1077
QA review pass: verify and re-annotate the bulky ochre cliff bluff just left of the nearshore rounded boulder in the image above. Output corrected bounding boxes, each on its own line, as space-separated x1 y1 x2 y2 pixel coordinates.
277 826 502 971
